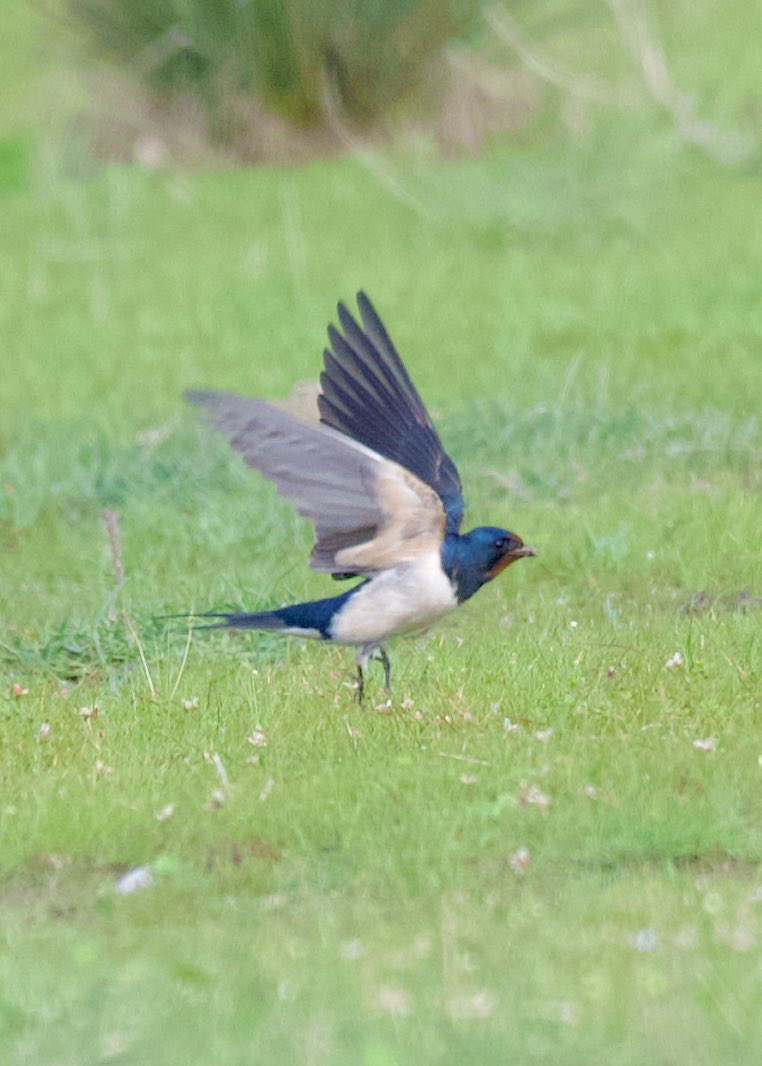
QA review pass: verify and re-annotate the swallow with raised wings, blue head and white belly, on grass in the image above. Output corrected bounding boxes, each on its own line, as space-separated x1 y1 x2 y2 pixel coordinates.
185 292 535 702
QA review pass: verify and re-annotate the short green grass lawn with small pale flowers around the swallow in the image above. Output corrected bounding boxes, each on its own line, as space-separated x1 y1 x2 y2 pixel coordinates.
0 4 762 1066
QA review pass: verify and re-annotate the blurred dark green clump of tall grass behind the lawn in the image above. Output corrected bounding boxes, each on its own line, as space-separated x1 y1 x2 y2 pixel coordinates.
67 0 479 126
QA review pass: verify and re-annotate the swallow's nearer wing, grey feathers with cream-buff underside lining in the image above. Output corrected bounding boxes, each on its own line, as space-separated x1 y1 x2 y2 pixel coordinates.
185 392 445 575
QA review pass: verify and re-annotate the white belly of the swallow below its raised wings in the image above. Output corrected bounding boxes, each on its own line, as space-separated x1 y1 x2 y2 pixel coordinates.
330 552 457 644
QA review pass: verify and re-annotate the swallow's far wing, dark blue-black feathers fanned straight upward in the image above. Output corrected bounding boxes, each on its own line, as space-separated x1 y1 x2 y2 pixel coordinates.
318 292 464 533
